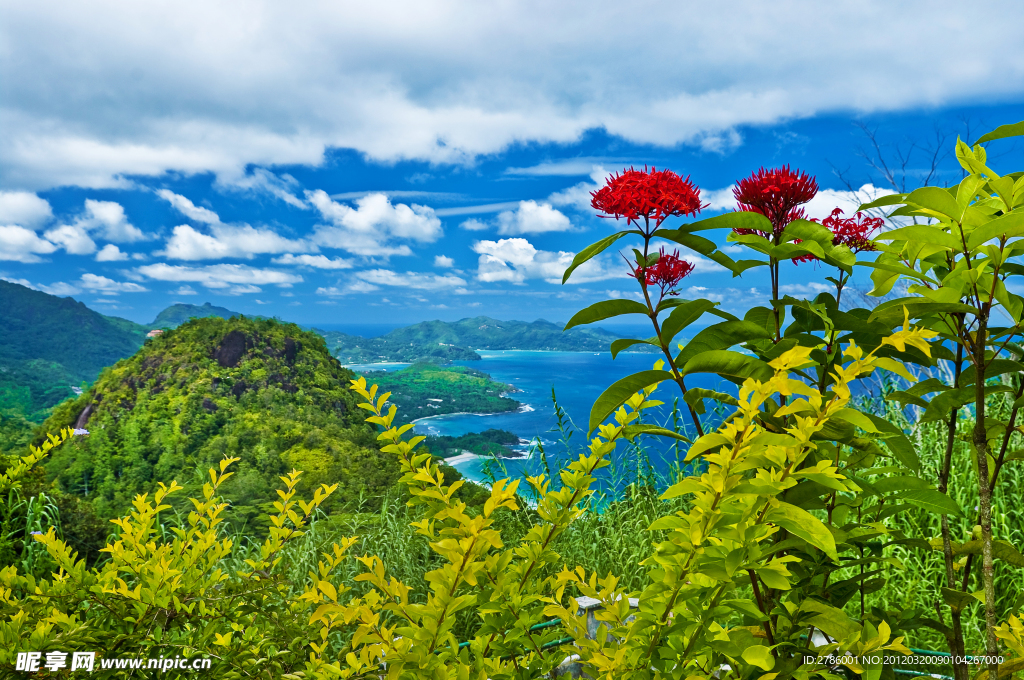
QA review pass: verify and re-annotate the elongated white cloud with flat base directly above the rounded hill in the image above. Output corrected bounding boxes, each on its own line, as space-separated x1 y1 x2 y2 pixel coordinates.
160 222 315 260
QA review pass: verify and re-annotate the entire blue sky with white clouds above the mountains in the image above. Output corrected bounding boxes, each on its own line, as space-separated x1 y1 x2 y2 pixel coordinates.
0 1 1024 325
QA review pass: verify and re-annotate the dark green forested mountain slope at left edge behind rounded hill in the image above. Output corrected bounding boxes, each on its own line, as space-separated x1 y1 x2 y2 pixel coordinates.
0 281 148 420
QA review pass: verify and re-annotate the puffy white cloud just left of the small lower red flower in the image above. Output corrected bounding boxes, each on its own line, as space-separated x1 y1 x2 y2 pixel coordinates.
473 239 626 284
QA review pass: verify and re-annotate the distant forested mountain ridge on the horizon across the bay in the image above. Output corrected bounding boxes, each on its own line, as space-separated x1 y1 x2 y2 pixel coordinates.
318 316 653 364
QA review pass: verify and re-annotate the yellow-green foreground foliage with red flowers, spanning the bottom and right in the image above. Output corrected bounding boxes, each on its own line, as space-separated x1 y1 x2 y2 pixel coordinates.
0 123 1024 680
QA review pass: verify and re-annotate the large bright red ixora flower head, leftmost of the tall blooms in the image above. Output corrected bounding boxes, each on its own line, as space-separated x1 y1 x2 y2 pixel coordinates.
590 166 706 230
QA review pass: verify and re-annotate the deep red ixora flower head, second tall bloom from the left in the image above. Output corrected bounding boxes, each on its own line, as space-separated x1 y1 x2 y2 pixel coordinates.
732 165 818 239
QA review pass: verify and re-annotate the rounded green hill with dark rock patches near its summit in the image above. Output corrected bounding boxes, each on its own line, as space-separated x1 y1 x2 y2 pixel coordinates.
44 316 396 522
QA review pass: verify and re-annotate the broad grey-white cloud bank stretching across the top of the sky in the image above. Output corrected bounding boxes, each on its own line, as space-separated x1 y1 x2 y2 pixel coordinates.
0 0 1024 188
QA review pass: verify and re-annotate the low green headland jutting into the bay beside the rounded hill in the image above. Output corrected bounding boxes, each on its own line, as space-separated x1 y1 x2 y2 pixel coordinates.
366 364 521 422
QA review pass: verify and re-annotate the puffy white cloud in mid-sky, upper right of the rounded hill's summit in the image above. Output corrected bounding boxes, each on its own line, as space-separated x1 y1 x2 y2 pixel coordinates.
305 189 441 257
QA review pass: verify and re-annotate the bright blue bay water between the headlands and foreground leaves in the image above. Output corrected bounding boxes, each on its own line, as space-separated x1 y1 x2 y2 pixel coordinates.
350 350 728 491
